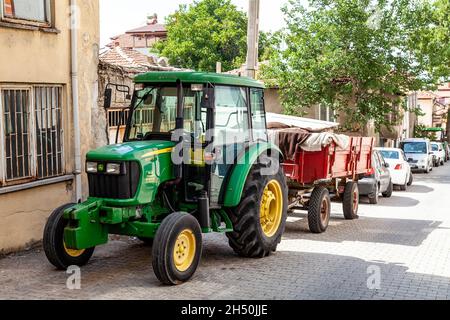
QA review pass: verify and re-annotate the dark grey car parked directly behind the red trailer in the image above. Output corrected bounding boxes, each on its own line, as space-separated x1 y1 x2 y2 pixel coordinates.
358 150 394 204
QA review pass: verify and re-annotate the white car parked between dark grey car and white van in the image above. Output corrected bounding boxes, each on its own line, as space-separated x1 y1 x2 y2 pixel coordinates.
376 148 413 191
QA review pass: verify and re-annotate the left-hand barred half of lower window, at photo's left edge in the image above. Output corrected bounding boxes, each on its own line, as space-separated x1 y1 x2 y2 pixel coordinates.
1 89 31 182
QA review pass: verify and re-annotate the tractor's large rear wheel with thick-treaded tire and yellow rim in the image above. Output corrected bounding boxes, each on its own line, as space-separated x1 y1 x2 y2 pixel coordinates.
227 159 288 258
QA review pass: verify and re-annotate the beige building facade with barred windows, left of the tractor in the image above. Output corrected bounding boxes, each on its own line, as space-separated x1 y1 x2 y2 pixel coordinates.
0 0 99 253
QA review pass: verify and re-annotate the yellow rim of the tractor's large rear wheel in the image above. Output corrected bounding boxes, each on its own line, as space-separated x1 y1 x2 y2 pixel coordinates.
260 180 283 238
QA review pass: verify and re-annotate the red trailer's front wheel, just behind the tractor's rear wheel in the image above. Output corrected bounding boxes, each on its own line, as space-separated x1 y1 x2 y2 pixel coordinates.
308 187 331 233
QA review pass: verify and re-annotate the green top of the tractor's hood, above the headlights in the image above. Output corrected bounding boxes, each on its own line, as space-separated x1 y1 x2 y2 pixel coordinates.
86 141 175 161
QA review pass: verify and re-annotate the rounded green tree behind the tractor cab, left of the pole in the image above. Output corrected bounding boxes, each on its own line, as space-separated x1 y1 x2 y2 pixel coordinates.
155 0 248 71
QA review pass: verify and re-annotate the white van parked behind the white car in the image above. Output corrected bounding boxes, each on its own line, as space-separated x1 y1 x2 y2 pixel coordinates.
400 139 434 173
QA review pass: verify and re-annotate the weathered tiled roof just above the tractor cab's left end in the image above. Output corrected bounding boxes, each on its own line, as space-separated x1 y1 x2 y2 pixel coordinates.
100 47 180 72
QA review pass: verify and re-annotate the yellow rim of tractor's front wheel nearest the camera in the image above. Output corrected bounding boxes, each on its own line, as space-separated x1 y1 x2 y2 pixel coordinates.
173 229 196 272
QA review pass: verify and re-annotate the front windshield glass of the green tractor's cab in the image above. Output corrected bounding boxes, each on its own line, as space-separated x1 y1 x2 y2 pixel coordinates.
127 86 206 141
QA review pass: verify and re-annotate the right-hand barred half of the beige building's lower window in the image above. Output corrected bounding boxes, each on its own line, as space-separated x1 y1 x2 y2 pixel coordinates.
34 87 64 179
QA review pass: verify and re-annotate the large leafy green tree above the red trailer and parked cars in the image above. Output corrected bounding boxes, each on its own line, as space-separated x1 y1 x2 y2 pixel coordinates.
262 0 448 131
